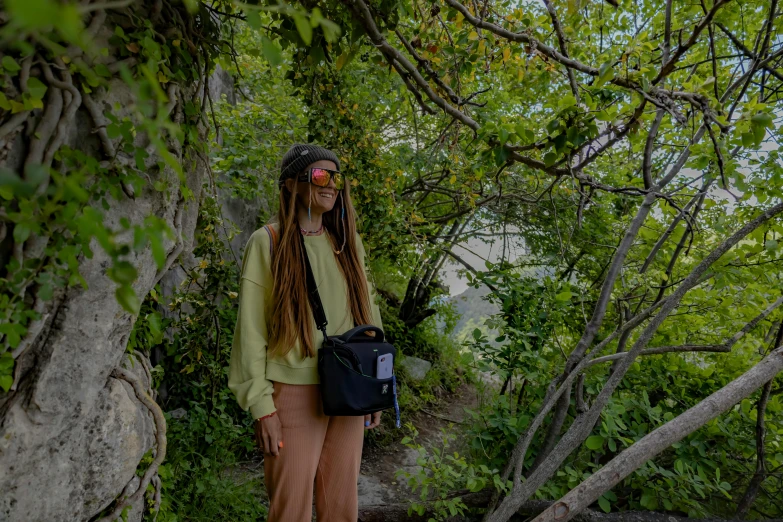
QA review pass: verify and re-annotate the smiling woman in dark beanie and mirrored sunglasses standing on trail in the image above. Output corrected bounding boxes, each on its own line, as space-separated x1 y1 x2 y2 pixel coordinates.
228 144 382 522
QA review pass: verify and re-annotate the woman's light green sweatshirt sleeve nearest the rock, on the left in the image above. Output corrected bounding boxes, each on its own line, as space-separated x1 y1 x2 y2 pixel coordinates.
228 228 275 419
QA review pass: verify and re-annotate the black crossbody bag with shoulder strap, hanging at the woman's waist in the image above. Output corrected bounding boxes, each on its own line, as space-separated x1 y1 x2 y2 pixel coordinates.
302 234 400 428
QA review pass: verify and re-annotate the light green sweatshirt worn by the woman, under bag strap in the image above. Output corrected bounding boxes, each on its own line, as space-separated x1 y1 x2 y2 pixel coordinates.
228 225 382 419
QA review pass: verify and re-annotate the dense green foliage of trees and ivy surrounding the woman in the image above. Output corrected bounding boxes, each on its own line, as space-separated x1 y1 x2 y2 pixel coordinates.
0 0 783 520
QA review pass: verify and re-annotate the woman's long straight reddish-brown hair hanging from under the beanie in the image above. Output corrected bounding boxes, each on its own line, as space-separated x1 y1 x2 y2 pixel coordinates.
267 183 372 358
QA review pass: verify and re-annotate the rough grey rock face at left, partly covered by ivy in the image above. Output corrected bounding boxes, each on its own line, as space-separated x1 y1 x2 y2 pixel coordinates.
0 22 206 522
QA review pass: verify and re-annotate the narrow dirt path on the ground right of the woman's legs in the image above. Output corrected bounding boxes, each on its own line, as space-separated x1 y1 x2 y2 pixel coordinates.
359 384 479 508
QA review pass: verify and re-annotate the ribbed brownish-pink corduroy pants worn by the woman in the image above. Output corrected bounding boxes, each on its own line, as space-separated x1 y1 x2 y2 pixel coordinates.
264 382 364 522
